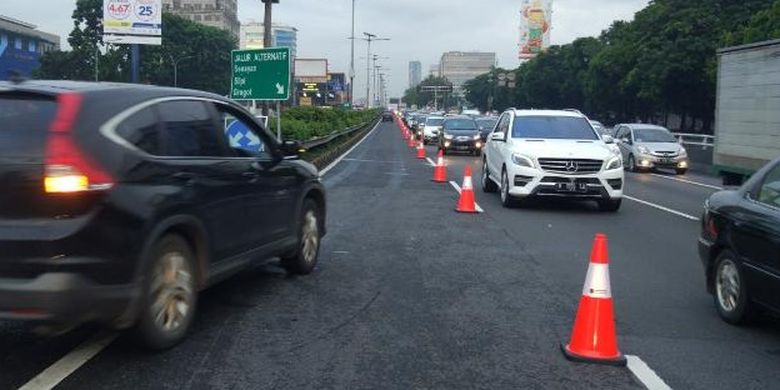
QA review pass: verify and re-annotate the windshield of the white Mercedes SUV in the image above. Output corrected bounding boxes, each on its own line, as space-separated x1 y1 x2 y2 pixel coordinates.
512 116 599 141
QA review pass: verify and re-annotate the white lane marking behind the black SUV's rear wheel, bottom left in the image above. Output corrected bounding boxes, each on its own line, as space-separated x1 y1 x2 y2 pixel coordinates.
19 333 118 390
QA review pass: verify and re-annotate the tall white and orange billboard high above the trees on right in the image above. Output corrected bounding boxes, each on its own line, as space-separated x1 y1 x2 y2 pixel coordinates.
520 0 552 60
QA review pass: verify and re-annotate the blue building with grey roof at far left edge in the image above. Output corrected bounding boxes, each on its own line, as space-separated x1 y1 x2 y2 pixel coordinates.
0 15 60 80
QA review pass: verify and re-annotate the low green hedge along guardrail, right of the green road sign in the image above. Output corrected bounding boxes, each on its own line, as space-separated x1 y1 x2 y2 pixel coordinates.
282 107 379 141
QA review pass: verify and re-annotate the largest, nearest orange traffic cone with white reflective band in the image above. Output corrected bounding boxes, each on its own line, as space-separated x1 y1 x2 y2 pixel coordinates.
561 233 626 366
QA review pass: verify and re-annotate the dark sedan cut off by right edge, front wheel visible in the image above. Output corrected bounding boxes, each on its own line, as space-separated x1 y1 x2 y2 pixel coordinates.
699 159 780 324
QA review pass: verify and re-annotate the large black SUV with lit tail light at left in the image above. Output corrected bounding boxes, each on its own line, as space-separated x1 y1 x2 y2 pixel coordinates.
0 81 326 349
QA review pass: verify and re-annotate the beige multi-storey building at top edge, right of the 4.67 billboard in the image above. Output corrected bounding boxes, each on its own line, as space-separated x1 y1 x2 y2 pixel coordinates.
163 0 241 38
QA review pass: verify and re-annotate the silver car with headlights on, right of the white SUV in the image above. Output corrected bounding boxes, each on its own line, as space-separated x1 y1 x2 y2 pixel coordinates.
615 123 690 175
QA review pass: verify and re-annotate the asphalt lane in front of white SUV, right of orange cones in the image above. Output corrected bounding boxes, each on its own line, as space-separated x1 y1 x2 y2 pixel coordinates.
470 169 780 389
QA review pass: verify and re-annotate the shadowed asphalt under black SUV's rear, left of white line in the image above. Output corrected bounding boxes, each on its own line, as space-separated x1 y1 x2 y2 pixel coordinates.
0 321 97 389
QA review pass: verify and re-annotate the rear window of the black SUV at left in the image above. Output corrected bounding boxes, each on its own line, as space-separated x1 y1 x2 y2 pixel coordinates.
0 93 57 157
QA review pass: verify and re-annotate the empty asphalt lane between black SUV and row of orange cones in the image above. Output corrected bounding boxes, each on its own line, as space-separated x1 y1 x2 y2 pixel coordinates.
63 122 640 389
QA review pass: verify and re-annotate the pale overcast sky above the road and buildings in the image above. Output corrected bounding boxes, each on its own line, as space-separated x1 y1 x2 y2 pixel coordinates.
0 0 649 96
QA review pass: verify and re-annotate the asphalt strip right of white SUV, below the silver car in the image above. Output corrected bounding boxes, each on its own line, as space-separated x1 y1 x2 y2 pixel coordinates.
623 172 718 218
